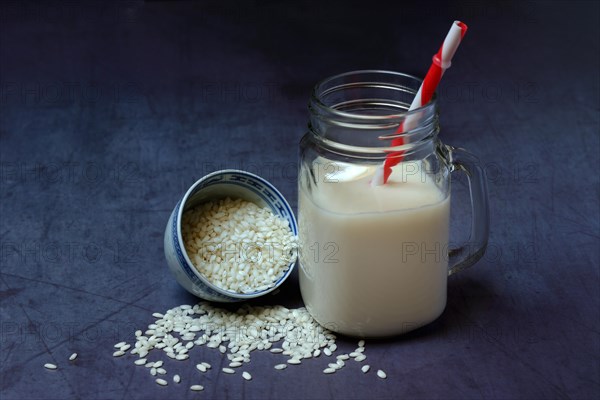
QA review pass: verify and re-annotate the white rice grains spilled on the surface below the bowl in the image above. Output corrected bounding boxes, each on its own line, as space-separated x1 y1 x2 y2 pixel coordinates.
113 300 376 387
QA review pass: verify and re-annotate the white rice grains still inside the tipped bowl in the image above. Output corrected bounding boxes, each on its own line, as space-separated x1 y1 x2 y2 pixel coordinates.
181 197 297 294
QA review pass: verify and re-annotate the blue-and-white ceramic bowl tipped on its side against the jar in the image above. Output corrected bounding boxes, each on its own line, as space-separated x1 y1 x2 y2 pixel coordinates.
164 169 298 302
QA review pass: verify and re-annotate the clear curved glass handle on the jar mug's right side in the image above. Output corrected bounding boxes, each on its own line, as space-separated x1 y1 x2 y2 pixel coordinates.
443 145 490 275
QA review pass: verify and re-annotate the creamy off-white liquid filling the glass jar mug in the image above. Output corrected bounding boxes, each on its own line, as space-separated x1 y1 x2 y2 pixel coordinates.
298 161 450 337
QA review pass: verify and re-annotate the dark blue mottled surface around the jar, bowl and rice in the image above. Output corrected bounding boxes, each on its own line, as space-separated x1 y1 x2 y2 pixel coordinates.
0 1 600 400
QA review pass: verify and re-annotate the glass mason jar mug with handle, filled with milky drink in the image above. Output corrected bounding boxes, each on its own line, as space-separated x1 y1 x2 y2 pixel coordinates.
298 71 489 337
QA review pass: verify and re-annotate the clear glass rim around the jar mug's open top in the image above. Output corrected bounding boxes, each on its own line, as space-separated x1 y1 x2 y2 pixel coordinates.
310 69 437 121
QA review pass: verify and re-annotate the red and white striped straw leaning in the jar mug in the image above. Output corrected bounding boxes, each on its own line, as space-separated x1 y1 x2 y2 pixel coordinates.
371 21 467 186
